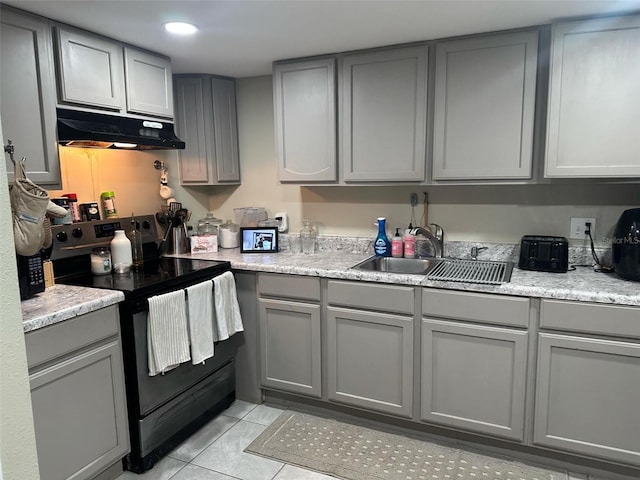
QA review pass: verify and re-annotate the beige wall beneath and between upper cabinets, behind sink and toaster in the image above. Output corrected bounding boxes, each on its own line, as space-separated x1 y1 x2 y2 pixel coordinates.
195 76 640 248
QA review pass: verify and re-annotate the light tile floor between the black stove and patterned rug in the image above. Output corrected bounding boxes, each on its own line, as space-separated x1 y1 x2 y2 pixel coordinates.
117 400 335 480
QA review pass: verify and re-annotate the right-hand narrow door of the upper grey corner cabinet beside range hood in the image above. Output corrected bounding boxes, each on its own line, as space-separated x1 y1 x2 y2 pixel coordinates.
211 78 240 183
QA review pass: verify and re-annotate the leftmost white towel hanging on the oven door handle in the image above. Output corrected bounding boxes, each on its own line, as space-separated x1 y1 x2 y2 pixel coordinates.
147 290 191 376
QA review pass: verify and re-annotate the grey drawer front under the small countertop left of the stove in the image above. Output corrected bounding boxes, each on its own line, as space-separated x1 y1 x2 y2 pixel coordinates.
25 305 120 369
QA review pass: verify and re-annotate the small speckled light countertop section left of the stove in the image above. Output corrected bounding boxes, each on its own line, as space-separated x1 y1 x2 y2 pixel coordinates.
22 285 124 333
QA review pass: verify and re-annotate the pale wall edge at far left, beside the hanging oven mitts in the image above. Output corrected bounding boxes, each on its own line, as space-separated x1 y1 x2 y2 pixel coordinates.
0 128 40 480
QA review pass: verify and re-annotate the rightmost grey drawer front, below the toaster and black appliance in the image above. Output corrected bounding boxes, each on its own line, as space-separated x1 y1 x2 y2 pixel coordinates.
540 300 640 338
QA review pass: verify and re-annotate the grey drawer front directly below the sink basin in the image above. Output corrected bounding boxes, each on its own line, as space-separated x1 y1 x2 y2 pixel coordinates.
328 280 415 315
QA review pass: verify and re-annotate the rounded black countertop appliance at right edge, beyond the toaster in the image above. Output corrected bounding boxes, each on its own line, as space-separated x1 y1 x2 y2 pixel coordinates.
612 208 640 282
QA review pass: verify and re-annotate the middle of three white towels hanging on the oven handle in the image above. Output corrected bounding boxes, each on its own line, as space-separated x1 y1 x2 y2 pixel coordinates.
187 280 213 365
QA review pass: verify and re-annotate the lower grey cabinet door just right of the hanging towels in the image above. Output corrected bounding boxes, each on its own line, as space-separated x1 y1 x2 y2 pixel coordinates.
259 299 321 397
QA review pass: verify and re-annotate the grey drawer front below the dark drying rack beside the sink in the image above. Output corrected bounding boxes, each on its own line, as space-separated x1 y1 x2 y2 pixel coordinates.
422 289 529 327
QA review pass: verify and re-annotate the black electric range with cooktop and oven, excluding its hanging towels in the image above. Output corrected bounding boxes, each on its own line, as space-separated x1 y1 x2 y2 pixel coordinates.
51 215 240 473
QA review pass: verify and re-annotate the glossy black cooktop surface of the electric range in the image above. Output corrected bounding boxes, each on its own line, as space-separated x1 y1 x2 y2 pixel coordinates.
54 257 231 297
